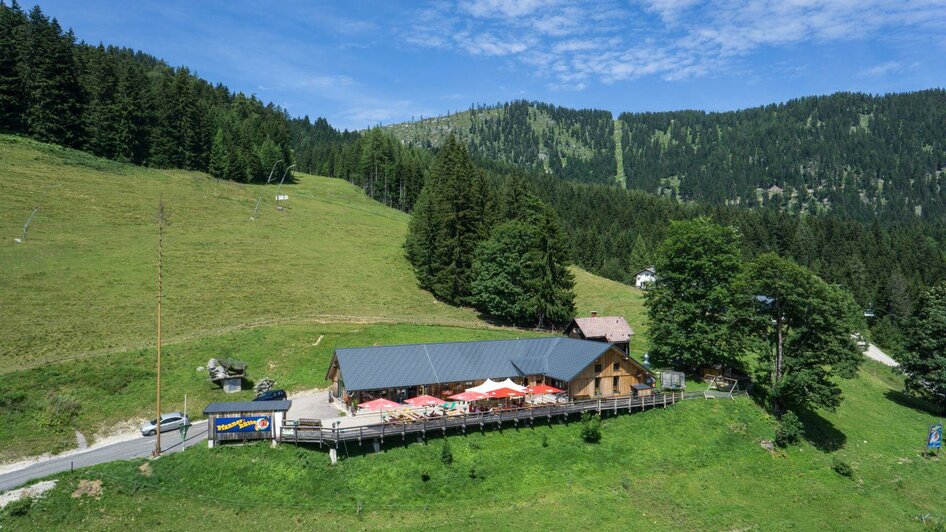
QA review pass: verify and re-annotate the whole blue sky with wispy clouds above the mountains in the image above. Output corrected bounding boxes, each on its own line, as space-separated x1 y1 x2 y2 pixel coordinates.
33 0 946 129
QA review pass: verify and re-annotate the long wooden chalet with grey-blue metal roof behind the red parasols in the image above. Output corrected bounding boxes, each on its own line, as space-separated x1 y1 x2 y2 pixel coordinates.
326 336 653 405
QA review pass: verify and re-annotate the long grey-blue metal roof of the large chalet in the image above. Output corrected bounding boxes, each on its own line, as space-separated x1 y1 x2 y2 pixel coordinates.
335 336 612 391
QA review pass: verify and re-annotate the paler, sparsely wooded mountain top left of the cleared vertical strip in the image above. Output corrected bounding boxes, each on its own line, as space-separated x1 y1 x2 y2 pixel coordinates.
384 100 617 184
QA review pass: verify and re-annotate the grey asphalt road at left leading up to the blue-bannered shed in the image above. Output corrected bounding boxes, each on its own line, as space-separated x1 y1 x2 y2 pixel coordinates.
0 421 207 492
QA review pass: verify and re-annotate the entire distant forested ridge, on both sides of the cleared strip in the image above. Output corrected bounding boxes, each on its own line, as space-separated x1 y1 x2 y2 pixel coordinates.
384 89 946 221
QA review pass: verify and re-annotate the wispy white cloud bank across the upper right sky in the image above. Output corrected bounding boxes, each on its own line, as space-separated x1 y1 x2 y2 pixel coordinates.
404 0 946 90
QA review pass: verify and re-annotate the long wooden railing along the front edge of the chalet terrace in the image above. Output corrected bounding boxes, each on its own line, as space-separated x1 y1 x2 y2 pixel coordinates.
279 392 703 446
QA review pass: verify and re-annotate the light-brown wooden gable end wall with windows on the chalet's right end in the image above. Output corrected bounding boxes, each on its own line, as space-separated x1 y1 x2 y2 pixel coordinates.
568 347 649 399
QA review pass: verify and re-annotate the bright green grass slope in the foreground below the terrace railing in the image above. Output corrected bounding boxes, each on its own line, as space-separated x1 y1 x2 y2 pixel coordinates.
3 365 946 530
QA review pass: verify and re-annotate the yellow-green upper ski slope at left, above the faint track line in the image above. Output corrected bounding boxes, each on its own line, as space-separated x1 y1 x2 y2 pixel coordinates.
0 137 482 370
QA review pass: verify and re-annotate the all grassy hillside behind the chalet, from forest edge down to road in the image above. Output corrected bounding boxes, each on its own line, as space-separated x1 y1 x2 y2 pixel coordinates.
0 136 642 460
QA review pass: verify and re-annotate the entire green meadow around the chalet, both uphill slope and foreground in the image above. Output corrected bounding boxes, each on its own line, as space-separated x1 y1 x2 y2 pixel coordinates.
0 136 946 530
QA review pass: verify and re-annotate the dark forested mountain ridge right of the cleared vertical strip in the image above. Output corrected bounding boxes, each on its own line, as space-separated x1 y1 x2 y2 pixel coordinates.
619 90 946 220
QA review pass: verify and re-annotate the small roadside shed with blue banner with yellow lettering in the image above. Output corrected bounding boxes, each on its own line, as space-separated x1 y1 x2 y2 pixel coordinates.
204 401 292 449
